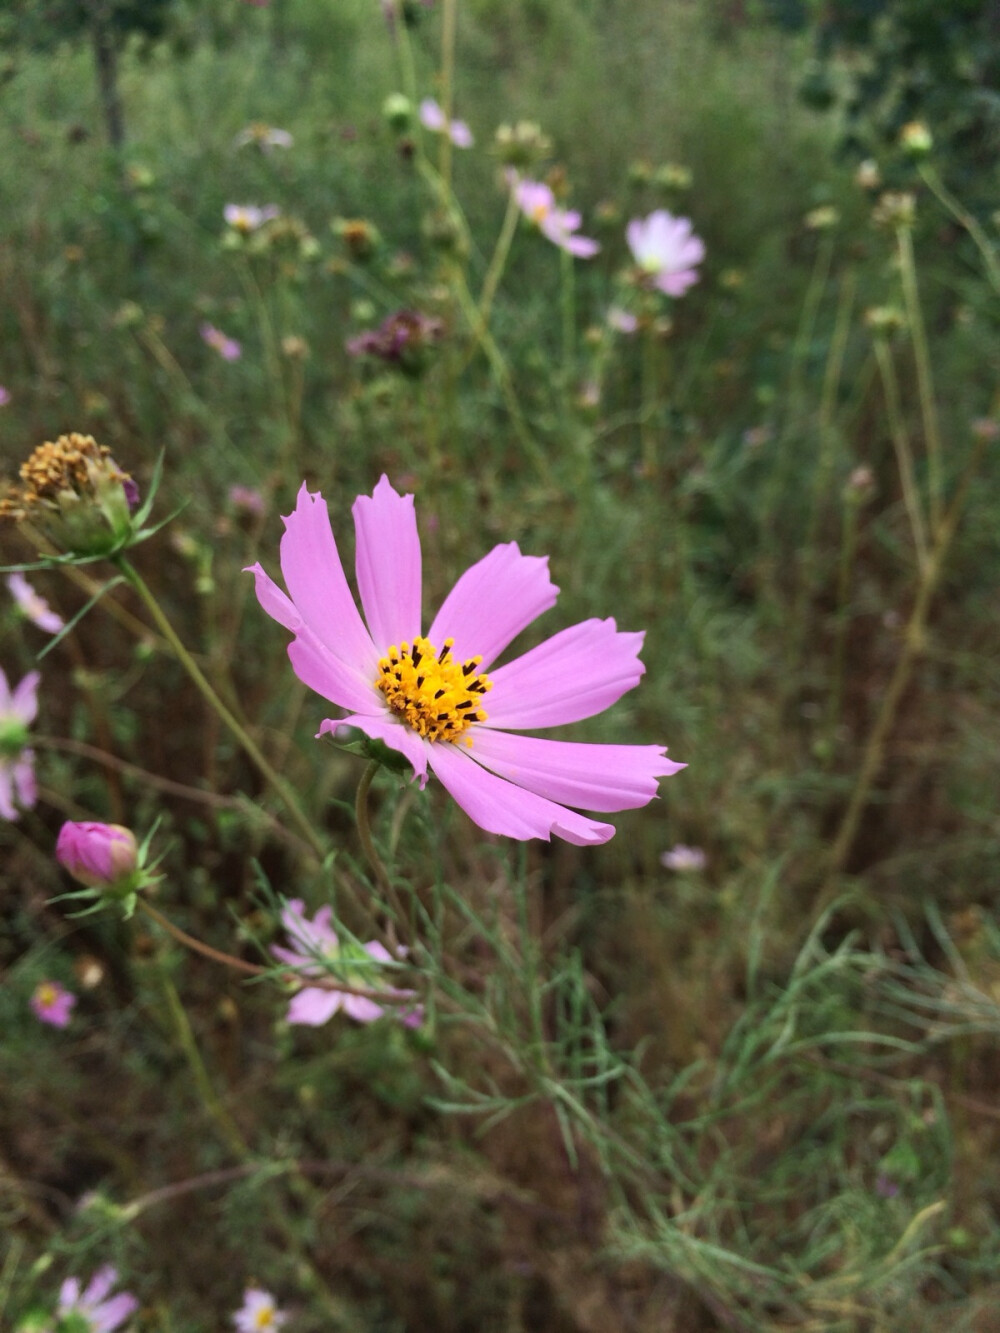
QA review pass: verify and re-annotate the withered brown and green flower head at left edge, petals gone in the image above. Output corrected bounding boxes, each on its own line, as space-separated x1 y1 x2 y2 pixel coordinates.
0 432 139 556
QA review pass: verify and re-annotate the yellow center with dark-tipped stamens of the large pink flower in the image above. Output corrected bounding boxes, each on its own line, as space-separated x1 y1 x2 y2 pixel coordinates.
375 636 493 745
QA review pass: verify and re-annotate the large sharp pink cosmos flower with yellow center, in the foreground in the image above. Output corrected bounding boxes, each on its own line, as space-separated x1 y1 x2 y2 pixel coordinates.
251 476 684 845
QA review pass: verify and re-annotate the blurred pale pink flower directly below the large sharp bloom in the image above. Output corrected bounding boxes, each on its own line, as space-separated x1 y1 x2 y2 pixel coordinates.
271 898 423 1028
